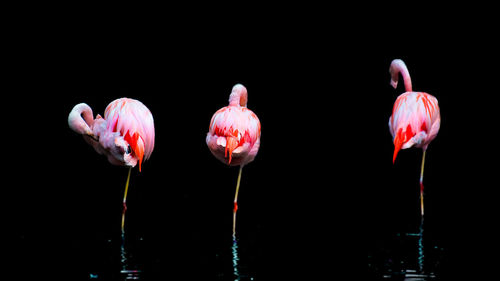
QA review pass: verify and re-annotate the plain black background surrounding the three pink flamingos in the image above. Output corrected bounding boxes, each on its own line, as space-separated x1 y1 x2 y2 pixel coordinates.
2 8 497 280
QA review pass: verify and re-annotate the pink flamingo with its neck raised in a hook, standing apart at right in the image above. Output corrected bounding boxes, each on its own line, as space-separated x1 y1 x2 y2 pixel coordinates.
389 59 441 216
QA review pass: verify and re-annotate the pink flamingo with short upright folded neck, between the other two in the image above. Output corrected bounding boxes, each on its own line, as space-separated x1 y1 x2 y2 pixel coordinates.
206 84 260 236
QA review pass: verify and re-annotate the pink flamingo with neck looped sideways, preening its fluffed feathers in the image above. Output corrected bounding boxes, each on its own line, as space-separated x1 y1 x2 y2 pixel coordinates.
68 98 155 233
